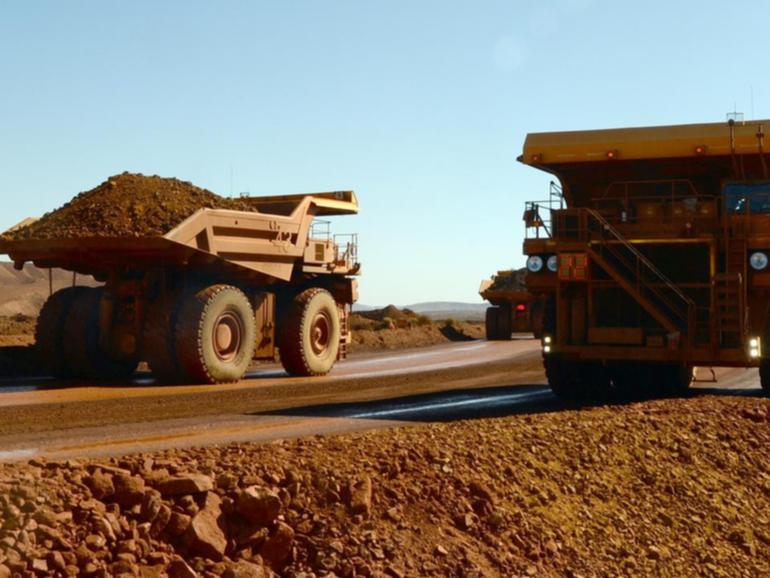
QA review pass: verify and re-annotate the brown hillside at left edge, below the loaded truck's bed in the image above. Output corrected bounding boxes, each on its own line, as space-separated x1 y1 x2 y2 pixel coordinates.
0 261 96 316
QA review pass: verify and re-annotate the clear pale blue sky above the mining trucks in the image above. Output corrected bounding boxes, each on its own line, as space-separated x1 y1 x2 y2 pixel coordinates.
0 0 770 304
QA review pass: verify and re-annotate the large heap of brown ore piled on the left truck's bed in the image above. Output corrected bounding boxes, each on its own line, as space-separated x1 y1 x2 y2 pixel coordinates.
5 173 253 240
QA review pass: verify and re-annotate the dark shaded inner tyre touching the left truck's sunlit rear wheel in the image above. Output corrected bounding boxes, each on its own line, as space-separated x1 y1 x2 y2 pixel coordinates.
143 299 184 383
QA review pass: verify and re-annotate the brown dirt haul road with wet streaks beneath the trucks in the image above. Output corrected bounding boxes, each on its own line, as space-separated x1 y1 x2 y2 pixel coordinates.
0 339 758 461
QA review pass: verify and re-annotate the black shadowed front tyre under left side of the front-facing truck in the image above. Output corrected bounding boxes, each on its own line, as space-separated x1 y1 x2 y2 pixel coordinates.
543 355 610 401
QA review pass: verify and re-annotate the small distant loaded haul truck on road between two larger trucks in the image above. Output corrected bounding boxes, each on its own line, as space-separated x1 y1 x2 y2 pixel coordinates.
479 270 543 341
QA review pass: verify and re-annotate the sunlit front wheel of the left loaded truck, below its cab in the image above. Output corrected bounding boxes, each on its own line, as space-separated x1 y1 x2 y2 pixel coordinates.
278 287 340 376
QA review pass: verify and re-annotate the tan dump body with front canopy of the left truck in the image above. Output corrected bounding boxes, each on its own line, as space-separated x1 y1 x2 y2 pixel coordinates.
0 191 358 282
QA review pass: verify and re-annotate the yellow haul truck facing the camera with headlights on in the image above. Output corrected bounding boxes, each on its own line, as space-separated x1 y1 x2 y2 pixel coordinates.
519 121 770 398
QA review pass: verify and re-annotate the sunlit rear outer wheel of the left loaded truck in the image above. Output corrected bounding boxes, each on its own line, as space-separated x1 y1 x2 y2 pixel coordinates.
174 285 257 383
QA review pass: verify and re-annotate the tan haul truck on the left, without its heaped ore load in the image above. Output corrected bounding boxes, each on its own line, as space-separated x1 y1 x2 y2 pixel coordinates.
0 191 360 383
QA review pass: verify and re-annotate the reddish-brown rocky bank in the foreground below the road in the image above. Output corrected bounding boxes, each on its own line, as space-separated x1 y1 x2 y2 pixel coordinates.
0 397 770 578
